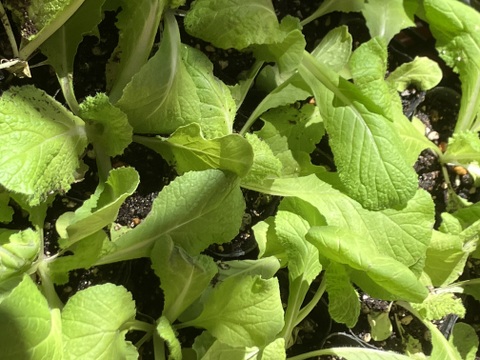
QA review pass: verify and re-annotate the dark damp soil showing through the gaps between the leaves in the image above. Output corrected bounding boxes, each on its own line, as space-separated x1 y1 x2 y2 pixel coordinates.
0 0 480 359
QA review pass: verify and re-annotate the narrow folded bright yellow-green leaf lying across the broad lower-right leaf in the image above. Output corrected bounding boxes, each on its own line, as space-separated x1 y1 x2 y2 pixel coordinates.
307 226 428 302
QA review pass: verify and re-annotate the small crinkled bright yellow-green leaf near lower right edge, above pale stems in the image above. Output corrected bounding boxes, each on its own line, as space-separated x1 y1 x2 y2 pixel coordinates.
412 293 465 321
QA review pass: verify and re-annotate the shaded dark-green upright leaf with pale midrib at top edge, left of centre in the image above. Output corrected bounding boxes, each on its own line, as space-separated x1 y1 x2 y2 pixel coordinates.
106 0 166 103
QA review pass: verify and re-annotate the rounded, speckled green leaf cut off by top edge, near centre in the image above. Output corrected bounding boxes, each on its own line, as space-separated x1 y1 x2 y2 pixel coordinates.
185 0 280 50
